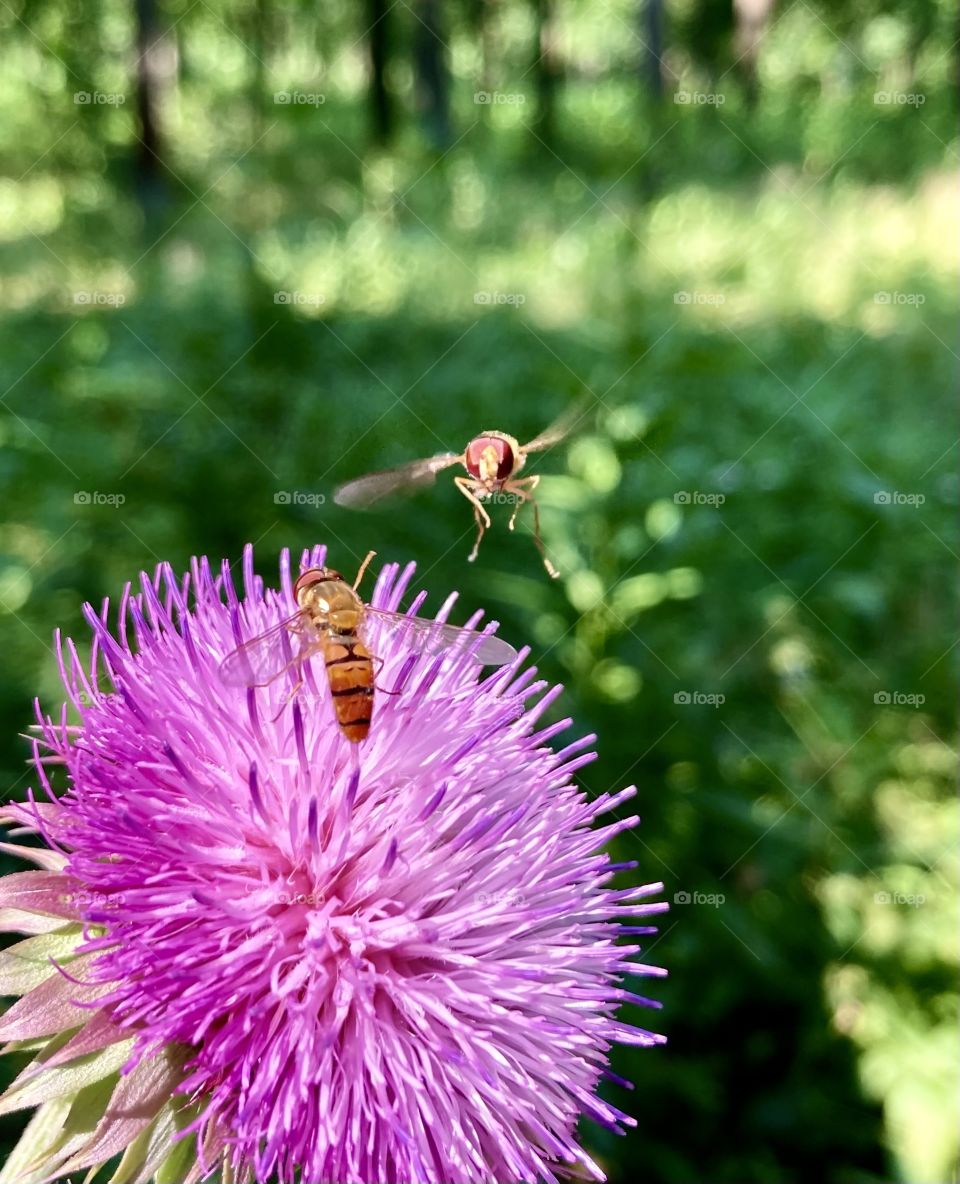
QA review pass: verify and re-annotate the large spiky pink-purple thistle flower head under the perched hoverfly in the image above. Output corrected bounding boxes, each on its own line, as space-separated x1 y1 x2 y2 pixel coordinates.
0 548 666 1184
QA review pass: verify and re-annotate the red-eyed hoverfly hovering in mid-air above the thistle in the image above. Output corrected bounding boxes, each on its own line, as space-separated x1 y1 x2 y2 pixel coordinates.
334 403 585 579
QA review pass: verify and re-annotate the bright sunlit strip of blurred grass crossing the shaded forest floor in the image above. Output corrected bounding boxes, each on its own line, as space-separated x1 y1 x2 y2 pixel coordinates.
0 153 960 335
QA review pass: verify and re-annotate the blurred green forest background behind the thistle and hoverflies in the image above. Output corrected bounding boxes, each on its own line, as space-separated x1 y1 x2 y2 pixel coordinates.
0 0 958 1184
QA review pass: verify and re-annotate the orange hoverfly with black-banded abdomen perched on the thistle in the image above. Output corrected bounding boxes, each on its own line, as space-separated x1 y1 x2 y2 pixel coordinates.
220 551 516 744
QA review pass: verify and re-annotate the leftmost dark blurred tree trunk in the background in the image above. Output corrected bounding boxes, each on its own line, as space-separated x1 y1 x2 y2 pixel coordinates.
134 0 178 212
